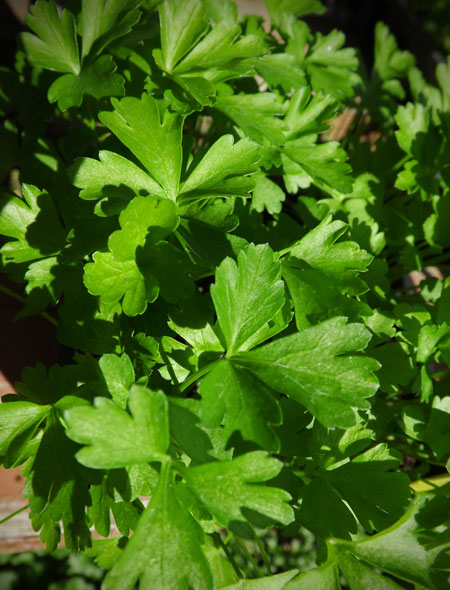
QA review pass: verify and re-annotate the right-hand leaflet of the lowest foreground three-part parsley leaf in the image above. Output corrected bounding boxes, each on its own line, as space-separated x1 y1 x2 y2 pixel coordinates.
183 451 293 530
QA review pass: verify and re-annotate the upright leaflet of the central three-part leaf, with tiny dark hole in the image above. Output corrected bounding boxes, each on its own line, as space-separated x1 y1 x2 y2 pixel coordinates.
211 244 286 356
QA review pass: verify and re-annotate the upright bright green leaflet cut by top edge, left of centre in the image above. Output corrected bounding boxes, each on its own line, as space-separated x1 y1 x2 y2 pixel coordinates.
158 0 208 73
